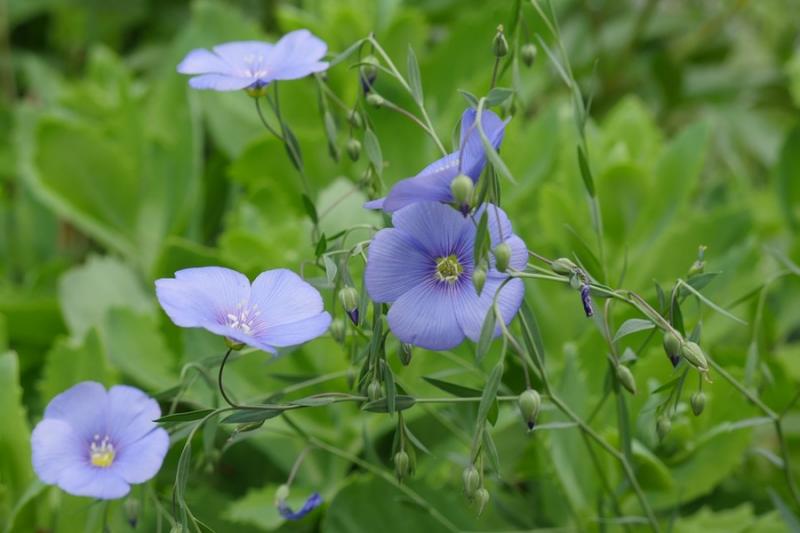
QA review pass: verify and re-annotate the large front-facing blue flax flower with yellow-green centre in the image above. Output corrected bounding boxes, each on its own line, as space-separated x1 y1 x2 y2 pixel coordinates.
366 202 528 350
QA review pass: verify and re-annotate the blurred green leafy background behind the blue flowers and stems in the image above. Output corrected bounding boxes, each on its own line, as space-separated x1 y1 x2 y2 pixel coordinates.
0 0 800 533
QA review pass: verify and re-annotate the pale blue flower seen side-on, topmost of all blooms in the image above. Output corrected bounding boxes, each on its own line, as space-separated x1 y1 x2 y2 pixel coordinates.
178 30 328 91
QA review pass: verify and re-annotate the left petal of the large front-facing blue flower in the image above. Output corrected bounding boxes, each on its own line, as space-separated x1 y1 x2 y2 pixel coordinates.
364 228 436 302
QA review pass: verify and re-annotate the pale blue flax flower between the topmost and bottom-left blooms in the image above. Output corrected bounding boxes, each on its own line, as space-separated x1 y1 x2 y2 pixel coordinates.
156 267 331 353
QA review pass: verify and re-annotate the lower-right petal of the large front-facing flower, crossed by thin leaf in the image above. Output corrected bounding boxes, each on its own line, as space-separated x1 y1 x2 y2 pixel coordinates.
456 277 525 342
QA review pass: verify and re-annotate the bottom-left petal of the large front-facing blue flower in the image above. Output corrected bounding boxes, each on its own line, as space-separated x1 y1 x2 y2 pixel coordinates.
386 281 464 350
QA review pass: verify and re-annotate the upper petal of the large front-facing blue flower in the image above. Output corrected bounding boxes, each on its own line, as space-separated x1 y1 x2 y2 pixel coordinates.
392 202 475 259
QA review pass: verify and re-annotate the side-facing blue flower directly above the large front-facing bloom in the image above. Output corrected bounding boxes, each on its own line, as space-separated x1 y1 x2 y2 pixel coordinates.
364 108 505 213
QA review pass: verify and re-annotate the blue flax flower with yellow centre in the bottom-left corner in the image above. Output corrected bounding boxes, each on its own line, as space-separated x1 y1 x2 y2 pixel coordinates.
31 381 169 500
